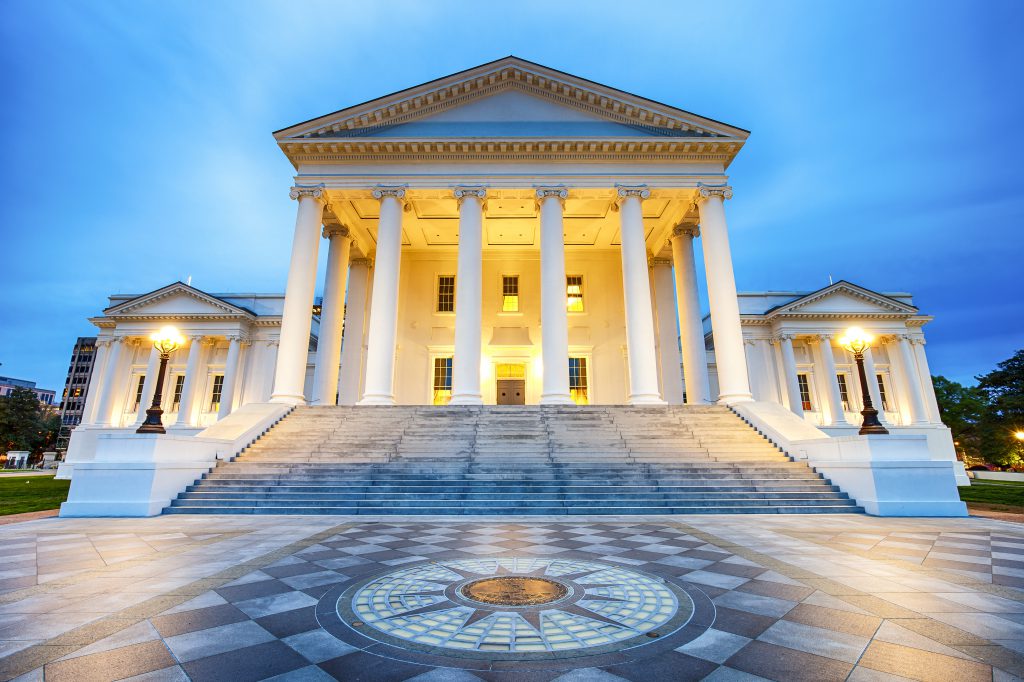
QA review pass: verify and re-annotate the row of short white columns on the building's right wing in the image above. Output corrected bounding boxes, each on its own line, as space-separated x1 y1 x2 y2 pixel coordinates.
771 334 939 426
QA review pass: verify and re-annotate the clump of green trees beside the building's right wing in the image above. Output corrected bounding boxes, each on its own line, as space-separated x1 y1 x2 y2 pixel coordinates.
932 349 1024 468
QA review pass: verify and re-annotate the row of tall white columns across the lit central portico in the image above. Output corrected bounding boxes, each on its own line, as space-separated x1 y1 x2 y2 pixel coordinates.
271 185 752 406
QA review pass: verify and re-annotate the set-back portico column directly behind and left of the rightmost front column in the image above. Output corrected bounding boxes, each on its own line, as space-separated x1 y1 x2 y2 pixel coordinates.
672 224 711 404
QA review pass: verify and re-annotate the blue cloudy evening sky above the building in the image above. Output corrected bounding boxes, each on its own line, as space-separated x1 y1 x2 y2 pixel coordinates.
0 0 1024 389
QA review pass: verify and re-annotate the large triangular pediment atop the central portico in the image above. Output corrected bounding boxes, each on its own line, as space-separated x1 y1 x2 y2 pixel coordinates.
274 56 749 143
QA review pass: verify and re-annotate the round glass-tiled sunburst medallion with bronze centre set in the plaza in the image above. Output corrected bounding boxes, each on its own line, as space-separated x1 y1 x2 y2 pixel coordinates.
337 557 692 657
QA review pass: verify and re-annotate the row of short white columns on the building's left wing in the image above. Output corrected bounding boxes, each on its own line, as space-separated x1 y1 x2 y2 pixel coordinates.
83 335 249 428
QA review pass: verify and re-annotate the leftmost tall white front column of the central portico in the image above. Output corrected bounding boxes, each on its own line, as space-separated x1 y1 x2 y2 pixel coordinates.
270 184 327 404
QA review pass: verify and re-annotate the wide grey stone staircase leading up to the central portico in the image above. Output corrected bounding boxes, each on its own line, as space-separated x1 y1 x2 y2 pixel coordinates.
164 406 862 515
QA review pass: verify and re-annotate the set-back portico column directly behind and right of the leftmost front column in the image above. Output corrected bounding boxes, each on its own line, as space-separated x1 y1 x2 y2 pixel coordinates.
309 224 352 404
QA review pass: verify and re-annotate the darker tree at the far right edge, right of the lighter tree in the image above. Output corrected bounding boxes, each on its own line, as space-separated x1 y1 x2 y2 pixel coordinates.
978 349 1024 468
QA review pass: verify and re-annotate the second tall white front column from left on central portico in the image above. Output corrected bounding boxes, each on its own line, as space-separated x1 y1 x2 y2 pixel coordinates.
358 187 406 404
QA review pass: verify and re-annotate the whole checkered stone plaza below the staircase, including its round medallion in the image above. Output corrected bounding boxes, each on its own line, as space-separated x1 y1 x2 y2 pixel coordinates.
0 515 1024 682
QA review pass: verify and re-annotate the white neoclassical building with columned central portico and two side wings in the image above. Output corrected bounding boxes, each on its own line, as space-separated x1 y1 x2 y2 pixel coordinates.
61 57 963 512
